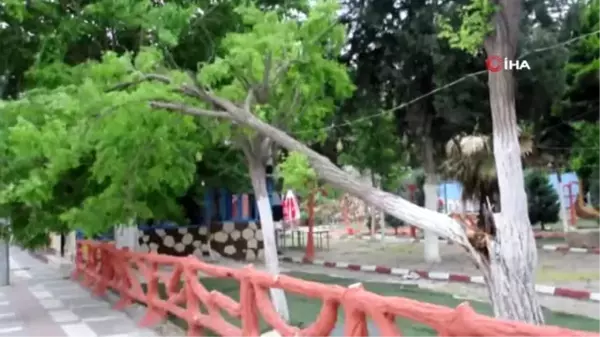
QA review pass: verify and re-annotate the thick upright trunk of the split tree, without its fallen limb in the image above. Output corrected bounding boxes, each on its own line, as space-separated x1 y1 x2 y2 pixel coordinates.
483 0 544 324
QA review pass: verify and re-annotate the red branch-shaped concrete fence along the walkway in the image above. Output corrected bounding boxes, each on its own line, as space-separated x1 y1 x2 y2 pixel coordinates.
73 241 600 337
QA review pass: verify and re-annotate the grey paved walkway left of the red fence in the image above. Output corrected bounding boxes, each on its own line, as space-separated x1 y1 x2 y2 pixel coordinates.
0 247 159 337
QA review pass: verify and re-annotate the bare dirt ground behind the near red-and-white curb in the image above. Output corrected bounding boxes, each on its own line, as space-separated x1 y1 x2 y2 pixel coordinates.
284 234 600 292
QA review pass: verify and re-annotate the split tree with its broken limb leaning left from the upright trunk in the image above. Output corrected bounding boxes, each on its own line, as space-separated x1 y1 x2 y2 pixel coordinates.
137 0 543 324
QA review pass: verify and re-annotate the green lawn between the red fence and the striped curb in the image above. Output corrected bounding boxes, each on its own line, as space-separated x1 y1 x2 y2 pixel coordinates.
148 272 600 337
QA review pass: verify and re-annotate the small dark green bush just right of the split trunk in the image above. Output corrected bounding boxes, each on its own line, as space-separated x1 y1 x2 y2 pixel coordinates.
525 171 560 230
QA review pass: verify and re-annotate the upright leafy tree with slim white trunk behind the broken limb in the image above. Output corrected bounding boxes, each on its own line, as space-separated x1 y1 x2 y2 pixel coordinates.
64 1 353 319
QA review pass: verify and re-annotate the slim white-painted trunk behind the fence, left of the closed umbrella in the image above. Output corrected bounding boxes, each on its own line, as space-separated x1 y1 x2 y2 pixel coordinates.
247 158 290 321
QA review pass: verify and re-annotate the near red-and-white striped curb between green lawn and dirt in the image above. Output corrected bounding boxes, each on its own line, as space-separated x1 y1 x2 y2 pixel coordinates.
280 256 600 302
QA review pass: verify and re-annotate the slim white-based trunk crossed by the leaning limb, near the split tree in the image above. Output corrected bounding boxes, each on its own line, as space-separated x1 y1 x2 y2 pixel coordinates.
423 136 442 263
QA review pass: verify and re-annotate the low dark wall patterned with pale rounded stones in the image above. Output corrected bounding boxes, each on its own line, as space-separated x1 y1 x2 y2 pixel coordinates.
138 221 264 261
